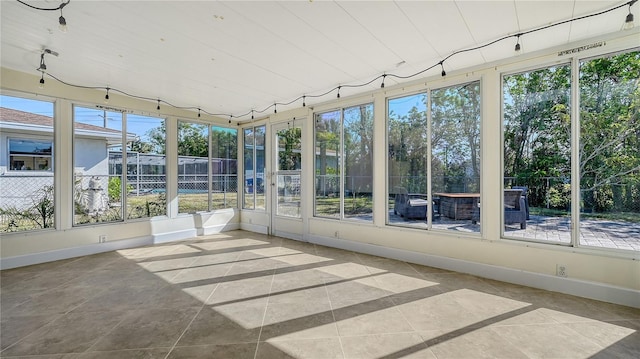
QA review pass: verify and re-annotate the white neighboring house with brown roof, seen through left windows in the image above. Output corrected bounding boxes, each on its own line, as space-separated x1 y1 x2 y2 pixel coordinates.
0 107 122 209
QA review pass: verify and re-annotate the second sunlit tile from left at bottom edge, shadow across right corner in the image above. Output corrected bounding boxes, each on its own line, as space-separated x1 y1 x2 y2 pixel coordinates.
340 333 436 359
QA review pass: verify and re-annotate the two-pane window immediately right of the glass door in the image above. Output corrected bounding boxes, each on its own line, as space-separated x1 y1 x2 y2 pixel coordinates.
314 104 373 222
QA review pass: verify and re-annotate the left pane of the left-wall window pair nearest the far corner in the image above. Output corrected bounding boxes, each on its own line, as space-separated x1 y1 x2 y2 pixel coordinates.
178 121 209 213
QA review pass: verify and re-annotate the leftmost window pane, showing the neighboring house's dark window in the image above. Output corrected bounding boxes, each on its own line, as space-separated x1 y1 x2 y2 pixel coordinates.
0 95 55 233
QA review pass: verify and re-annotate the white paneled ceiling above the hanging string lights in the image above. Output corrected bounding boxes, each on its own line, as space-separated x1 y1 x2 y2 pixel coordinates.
0 0 640 120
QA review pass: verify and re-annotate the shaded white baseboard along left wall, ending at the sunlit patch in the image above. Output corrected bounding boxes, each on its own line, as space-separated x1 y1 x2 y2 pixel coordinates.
0 236 153 270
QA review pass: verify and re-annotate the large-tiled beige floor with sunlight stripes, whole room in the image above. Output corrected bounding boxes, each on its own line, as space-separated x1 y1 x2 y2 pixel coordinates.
0 231 640 359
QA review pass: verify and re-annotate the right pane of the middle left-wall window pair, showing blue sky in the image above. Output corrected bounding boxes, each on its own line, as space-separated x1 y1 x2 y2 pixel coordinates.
126 114 167 219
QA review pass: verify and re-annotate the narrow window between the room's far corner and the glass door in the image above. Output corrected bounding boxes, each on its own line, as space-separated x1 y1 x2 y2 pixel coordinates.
242 126 266 210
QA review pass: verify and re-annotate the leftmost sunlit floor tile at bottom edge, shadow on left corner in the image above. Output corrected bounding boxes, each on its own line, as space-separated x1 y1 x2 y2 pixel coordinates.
256 338 344 359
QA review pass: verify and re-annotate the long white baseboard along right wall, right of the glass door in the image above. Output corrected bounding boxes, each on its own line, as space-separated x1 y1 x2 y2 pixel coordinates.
308 235 640 308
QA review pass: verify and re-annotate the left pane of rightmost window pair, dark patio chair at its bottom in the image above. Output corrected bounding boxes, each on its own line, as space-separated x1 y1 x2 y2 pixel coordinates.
503 65 571 243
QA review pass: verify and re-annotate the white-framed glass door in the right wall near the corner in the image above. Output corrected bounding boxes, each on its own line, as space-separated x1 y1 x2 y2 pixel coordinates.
271 120 303 238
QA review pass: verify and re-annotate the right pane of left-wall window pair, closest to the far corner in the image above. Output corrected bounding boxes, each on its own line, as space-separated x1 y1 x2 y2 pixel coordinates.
211 126 238 209
